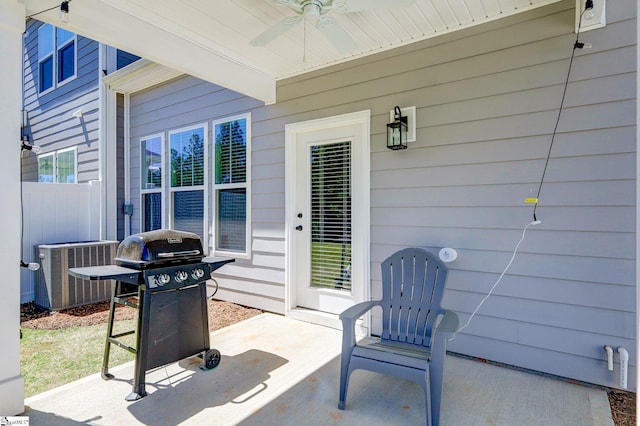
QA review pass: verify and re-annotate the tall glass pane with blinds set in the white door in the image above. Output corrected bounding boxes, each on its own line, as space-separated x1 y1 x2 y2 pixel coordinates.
310 141 351 291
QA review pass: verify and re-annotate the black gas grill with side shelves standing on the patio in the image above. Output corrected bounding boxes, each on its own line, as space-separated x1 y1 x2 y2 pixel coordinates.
69 229 234 401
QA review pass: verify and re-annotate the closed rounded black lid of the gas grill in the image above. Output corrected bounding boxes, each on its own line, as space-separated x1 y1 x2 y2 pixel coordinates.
115 229 204 269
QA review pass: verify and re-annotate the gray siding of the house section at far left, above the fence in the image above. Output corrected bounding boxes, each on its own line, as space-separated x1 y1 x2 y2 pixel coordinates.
23 19 99 182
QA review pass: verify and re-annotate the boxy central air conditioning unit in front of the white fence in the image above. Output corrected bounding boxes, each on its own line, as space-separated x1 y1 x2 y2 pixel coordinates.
35 241 119 311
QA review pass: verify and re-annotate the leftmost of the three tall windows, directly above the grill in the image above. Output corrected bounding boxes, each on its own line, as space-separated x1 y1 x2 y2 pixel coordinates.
140 135 164 232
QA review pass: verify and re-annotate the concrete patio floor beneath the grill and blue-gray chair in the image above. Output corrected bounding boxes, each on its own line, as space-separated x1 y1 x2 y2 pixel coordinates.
23 314 613 426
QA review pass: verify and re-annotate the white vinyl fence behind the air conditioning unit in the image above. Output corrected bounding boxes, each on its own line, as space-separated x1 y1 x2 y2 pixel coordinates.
20 181 100 303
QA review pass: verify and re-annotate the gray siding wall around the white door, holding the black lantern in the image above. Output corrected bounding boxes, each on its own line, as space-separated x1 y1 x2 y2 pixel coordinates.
131 0 637 389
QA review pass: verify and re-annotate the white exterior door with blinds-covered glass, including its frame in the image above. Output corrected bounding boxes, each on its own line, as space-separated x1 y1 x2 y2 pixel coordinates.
286 111 370 322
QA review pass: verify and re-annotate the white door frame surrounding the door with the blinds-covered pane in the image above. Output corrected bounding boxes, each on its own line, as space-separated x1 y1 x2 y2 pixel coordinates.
285 110 371 329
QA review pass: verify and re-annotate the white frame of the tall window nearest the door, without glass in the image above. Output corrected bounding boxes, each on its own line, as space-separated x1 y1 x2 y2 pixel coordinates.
211 112 252 259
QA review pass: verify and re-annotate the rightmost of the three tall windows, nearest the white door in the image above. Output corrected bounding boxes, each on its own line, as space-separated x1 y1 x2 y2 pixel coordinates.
213 114 251 255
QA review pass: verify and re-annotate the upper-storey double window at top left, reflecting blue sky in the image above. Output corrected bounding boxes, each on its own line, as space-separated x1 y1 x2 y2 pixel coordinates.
38 24 77 93
